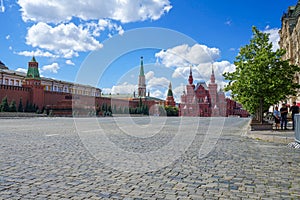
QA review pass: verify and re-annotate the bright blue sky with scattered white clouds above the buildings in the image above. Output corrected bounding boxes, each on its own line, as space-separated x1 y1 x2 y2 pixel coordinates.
0 0 297 100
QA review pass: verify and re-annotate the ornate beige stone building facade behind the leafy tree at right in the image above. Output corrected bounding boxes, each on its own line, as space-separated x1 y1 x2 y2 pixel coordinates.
279 1 300 105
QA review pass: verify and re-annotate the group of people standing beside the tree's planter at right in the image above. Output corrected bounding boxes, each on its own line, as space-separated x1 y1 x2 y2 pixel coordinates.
273 102 299 130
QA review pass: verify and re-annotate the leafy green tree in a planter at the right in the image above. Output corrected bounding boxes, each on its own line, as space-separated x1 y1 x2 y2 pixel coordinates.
223 27 300 123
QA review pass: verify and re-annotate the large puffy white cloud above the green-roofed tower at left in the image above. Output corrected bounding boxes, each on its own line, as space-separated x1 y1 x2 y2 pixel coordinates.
26 22 102 58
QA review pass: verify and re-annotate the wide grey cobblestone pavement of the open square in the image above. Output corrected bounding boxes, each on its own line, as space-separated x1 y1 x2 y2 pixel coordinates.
0 117 300 199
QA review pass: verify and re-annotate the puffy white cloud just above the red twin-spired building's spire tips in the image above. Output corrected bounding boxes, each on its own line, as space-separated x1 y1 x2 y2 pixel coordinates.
155 44 220 67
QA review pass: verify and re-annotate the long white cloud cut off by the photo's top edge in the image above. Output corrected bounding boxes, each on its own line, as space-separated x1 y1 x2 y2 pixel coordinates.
18 0 172 23
